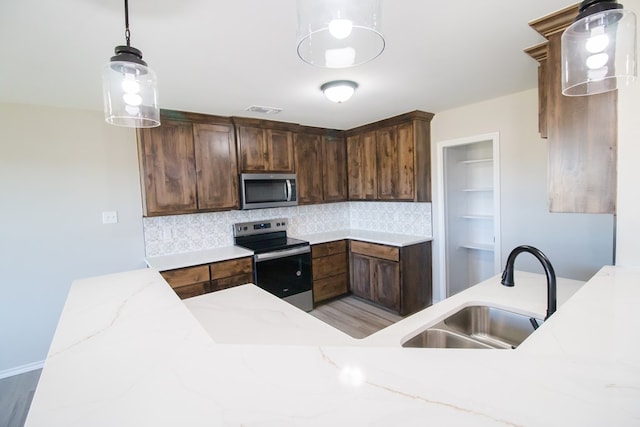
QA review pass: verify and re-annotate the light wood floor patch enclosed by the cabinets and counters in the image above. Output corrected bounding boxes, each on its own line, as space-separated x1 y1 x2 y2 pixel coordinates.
309 295 402 338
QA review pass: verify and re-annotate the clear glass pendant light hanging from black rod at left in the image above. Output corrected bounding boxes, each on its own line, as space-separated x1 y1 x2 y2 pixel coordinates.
102 0 160 128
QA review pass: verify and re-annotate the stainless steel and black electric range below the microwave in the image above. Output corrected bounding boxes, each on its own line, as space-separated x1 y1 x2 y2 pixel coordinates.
233 218 313 311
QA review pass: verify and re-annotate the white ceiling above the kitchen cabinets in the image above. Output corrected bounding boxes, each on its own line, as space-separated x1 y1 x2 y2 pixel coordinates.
0 0 575 129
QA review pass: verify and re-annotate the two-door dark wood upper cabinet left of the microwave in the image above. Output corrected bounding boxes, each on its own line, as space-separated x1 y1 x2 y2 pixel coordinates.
138 110 239 216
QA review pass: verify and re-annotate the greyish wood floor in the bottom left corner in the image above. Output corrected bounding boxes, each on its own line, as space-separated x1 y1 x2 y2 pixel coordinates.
0 369 42 427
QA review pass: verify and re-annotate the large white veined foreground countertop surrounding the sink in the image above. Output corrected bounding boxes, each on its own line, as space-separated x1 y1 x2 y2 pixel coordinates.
26 267 640 427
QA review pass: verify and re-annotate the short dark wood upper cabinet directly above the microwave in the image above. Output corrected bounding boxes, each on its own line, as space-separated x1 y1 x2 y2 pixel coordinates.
233 118 295 173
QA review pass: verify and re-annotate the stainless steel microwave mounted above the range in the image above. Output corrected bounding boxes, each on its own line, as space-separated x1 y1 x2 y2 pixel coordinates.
240 173 298 209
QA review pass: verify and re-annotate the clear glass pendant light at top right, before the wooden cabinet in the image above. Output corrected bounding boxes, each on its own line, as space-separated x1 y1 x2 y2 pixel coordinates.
561 0 637 96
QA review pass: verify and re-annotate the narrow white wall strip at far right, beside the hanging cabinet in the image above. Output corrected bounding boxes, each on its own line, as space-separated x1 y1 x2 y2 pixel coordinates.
616 0 640 267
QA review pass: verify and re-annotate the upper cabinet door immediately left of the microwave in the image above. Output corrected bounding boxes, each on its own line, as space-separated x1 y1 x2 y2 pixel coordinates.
193 123 239 210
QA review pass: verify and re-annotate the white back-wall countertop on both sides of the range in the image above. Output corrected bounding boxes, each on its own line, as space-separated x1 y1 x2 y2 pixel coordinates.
146 229 432 271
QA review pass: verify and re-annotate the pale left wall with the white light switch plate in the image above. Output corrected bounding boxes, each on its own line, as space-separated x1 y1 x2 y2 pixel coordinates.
0 104 145 376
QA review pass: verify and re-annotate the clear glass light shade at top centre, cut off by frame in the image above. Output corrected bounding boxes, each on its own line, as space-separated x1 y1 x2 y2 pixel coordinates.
298 0 385 68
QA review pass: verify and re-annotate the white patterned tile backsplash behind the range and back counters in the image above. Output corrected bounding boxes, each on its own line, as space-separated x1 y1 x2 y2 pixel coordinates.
143 202 432 257
